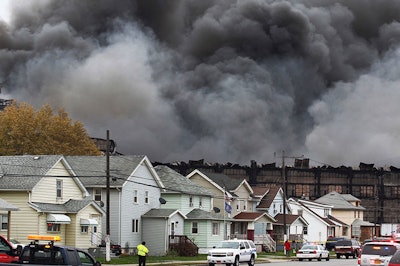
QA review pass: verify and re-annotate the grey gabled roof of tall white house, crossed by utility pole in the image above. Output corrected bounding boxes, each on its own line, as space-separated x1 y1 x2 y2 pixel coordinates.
66 155 163 188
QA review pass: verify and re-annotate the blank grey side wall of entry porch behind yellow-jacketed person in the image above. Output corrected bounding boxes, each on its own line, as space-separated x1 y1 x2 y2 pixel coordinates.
142 218 169 256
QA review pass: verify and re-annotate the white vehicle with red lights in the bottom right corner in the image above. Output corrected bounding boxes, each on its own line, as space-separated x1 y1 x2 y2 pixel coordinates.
358 242 400 266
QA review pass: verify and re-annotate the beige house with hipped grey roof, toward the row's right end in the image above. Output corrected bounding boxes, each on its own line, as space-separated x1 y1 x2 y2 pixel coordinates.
315 191 365 238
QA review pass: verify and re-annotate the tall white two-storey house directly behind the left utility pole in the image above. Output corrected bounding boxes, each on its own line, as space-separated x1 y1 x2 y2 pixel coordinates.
66 155 164 251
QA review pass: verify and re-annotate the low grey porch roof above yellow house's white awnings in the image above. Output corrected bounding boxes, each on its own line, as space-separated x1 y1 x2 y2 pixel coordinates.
28 197 105 214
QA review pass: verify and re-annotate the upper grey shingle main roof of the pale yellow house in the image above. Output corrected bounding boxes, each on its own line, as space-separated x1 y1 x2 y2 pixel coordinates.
0 155 63 191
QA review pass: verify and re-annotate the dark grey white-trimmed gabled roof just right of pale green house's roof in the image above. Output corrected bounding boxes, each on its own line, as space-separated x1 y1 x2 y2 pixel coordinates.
187 169 253 196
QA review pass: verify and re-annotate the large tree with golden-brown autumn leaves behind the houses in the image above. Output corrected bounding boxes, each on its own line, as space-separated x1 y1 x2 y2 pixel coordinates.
0 103 101 155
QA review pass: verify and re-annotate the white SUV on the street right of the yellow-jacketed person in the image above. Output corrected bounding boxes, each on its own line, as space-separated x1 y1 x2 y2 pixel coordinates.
207 239 257 266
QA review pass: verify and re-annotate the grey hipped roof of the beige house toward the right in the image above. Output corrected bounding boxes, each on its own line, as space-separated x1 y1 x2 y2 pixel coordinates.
315 191 365 210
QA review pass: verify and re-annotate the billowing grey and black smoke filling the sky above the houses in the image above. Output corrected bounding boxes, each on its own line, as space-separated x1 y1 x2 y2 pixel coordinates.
0 0 400 167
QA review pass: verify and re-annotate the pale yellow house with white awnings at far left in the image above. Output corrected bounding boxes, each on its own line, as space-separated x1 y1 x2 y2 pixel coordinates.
0 155 104 248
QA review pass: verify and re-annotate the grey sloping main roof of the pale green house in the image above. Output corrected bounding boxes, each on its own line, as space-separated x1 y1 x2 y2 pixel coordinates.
154 165 213 197
